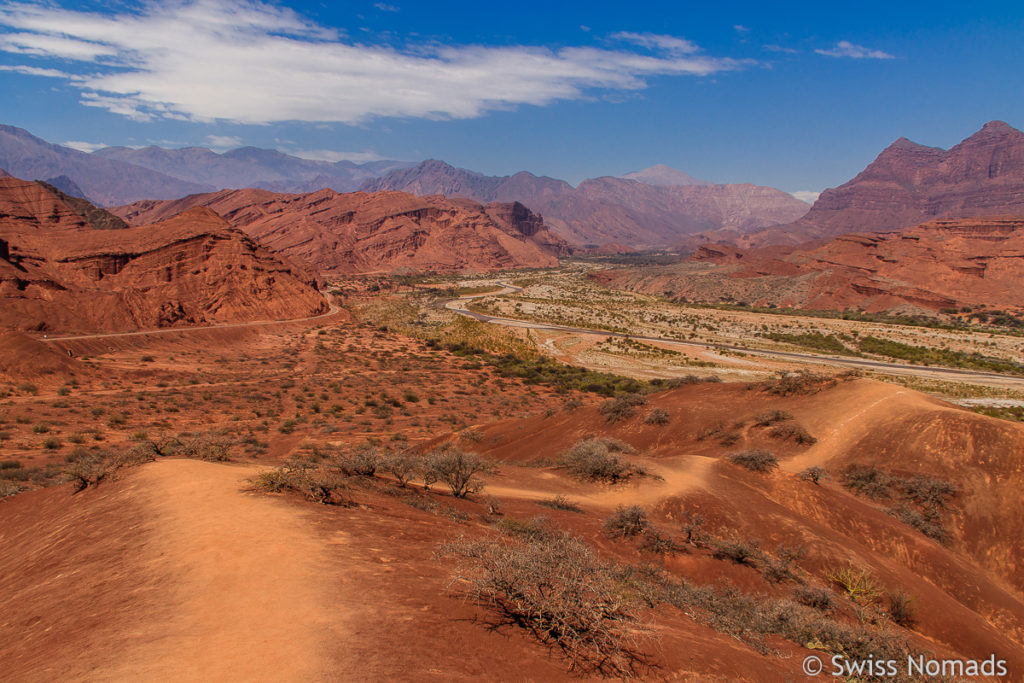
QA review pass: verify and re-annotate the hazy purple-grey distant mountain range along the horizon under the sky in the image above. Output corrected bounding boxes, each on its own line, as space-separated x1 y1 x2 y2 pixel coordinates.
0 126 807 247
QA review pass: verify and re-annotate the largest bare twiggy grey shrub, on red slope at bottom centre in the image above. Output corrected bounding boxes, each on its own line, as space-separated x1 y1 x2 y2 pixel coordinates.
439 536 640 676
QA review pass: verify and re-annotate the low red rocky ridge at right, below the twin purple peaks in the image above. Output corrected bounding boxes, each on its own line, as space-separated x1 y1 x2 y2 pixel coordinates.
609 216 1024 312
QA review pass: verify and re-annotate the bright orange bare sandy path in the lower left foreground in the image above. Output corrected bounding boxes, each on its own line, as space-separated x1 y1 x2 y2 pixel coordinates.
97 460 345 681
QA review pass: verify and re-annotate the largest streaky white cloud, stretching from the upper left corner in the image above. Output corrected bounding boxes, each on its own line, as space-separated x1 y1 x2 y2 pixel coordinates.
0 0 751 124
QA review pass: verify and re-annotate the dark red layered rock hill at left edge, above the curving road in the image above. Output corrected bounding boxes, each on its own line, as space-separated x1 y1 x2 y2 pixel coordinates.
0 178 327 332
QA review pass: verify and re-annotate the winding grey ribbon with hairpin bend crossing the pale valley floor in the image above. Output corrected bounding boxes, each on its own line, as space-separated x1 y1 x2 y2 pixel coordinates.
439 283 1024 387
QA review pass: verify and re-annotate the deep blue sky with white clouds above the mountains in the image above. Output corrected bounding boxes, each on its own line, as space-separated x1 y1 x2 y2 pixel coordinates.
0 0 1024 196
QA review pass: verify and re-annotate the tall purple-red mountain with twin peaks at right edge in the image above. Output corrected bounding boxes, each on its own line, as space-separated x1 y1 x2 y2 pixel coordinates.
738 121 1024 246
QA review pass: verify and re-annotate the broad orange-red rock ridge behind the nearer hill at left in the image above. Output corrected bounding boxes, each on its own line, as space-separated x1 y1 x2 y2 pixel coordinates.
115 189 569 272
